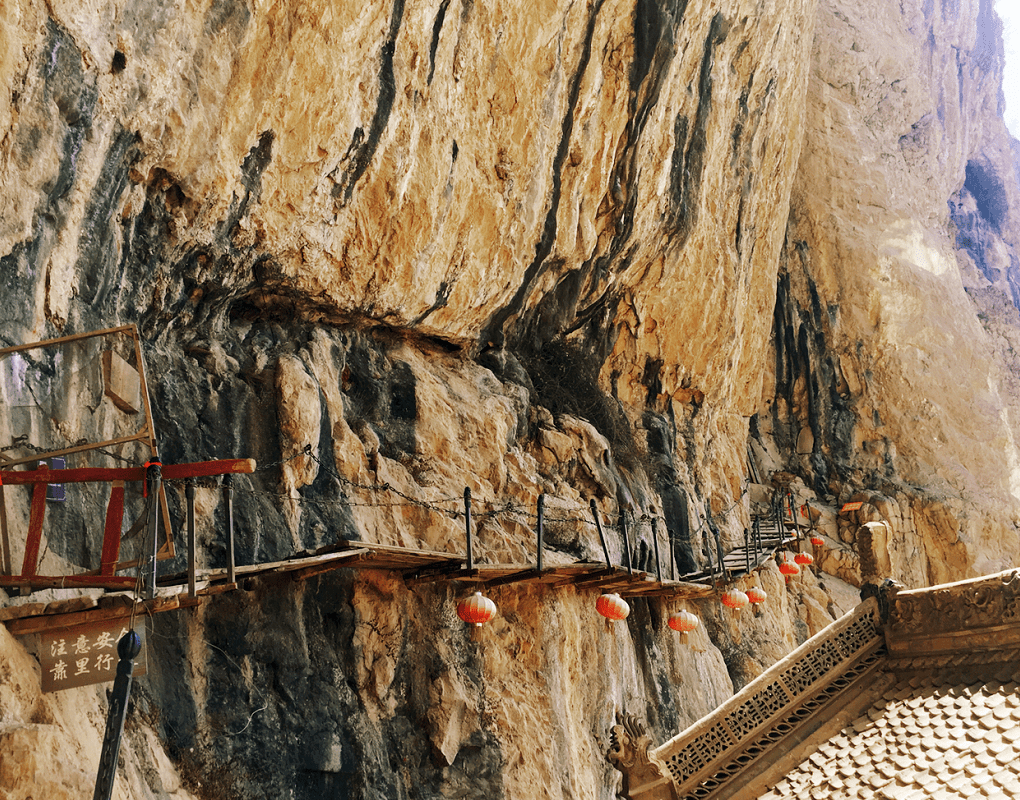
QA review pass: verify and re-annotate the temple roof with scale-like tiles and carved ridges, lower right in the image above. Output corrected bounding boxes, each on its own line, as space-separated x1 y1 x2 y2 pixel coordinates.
610 570 1020 800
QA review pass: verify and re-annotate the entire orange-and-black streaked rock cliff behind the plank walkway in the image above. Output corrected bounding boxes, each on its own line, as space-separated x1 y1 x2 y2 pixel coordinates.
0 0 1020 798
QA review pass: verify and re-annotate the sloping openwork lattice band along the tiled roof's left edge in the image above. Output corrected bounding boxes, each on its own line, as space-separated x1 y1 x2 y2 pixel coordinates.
654 602 882 798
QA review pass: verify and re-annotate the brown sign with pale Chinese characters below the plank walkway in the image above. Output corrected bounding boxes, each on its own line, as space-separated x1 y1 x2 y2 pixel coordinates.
39 619 145 692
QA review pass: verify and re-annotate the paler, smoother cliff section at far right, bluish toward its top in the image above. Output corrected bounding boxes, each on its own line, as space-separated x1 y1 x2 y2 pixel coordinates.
760 3 1018 586
